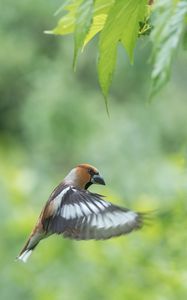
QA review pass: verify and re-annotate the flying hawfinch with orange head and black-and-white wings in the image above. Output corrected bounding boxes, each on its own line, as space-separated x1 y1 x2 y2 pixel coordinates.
17 164 144 262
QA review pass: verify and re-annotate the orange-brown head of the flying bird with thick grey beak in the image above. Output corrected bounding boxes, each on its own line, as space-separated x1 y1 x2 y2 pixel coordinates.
64 164 105 189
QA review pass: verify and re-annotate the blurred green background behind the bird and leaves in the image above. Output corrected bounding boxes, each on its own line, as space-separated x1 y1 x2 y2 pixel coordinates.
0 0 187 300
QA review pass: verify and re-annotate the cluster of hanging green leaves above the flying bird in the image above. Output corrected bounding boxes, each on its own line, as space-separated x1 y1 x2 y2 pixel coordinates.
46 0 187 99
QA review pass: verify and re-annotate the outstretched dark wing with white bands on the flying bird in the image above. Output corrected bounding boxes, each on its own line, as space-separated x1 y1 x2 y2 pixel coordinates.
43 188 143 240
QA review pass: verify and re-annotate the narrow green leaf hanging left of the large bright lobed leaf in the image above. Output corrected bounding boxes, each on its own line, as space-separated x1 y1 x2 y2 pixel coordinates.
73 0 93 67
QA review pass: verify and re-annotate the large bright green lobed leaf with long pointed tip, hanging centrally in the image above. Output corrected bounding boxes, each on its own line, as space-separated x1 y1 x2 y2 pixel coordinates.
98 0 147 98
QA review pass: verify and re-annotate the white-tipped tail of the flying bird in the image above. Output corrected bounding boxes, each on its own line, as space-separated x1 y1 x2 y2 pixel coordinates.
17 233 43 263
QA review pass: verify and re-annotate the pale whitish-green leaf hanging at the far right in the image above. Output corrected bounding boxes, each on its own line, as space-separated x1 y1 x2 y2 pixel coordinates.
151 0 187 97
